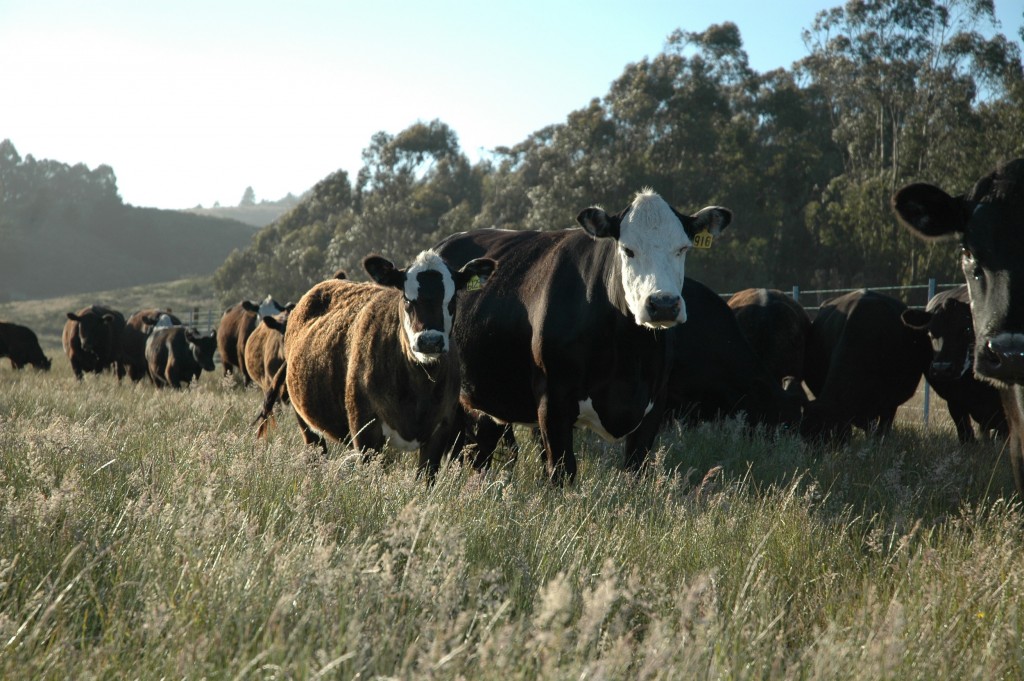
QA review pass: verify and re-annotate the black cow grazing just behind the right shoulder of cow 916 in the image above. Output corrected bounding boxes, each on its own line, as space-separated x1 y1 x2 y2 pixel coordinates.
667 278 803 427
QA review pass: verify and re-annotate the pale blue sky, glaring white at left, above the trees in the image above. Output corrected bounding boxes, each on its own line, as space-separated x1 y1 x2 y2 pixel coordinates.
6 0 1024 209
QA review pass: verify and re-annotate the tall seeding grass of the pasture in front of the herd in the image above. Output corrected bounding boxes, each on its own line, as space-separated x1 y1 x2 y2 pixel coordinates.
0 358 1024 679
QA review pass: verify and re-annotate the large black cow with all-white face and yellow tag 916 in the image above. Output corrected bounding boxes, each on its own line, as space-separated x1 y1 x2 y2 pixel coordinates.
437 189 732 484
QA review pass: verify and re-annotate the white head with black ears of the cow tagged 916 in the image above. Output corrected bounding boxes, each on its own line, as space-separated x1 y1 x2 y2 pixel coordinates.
577 189 732 329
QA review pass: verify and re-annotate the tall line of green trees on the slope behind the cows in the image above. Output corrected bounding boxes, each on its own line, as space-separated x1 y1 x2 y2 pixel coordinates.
184 0 1024 301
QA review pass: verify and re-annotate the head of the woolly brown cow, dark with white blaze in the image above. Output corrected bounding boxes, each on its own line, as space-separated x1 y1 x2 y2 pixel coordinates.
362 251 496 364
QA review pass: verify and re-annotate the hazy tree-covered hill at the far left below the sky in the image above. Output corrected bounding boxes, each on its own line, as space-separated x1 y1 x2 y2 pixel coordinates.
0 140 255 300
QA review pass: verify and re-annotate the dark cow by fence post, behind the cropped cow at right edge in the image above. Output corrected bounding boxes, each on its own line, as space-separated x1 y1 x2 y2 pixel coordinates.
902 285 1010 442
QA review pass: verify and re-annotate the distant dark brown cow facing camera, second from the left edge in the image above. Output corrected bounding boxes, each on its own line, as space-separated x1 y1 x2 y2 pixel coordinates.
61 305 125 381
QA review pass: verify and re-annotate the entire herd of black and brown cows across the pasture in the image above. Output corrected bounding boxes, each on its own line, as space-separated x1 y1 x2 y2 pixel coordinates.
0 160 1024 491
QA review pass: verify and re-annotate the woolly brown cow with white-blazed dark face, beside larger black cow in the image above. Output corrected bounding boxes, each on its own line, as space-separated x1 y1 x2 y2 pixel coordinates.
261 250 495 479
